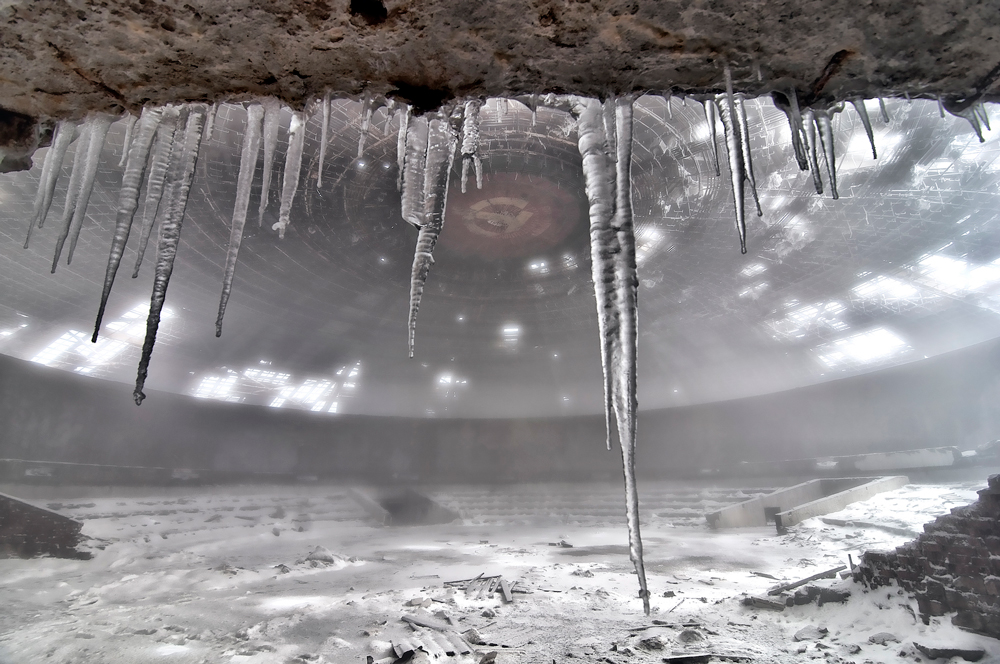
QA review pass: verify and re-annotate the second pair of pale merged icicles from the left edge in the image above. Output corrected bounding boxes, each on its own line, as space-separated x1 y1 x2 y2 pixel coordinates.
52 114 111 272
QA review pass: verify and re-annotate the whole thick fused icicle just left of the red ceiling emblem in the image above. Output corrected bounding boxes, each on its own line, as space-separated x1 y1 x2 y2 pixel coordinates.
402 109 462 357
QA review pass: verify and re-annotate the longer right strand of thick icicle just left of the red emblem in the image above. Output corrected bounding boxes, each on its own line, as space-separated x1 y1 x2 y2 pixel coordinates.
403 110 462 357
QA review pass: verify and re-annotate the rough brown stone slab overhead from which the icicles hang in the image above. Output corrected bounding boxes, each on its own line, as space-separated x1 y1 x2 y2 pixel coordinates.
0 0 1000 123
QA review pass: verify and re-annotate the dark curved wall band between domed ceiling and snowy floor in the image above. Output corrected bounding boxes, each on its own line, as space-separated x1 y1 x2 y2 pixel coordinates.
0 334 1000 481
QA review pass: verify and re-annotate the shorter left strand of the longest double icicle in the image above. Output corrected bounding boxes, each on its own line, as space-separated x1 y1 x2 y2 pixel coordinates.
571 97 620 450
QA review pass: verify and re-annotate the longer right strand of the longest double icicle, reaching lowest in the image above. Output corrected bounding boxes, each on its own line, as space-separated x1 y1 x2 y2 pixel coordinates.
612 96 649 616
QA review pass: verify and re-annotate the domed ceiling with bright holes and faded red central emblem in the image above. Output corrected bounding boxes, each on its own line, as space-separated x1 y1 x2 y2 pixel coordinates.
0 96 1000 417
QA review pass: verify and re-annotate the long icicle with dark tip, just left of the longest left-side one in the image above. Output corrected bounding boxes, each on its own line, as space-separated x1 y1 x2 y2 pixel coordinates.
90 108 163 343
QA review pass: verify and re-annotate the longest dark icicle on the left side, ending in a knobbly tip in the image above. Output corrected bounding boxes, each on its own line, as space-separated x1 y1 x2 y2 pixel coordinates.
132 108 205 406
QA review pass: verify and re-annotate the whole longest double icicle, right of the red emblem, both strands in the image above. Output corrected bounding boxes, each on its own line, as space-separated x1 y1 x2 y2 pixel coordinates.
570 97 650 615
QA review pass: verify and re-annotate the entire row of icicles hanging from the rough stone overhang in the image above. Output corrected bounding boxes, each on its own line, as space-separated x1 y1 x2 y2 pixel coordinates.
17 85 989 614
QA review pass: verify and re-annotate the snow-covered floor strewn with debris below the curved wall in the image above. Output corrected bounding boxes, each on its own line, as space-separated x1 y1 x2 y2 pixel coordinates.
0 481 1000 664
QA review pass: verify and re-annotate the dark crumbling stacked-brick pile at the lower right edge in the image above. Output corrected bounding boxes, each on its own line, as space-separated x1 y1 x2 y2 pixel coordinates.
854 475 1000 638
